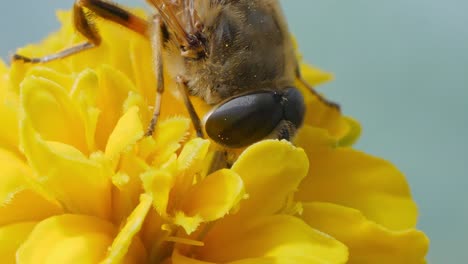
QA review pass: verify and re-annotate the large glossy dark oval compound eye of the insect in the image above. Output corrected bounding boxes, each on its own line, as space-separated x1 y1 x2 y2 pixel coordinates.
205 90 284 148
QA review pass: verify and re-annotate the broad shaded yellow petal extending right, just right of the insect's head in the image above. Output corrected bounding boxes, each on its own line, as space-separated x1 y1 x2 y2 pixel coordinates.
296 127 417 229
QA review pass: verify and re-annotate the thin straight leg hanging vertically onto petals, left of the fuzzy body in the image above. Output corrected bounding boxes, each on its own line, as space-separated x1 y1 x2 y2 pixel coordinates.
145 14 164 136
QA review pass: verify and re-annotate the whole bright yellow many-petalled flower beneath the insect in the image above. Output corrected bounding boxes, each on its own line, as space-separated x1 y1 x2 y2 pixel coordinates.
0 9 428 264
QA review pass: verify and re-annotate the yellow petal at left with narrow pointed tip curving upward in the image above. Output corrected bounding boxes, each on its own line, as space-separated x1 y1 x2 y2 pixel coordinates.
20 119 111 219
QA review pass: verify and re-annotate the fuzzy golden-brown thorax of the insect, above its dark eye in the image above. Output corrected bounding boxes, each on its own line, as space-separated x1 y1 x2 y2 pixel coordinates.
159 0 296 104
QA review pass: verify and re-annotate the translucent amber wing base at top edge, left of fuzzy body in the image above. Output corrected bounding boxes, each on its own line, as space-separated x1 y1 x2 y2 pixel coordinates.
148 0 203 47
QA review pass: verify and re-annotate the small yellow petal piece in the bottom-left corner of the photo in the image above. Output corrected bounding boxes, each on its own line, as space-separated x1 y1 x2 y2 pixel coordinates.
0 222 36 263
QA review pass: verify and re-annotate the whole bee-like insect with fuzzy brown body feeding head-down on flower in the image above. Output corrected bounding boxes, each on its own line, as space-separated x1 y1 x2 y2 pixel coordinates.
13 0 338 148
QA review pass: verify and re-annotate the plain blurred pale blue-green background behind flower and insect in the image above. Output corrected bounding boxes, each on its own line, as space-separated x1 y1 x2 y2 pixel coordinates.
0 0 468 263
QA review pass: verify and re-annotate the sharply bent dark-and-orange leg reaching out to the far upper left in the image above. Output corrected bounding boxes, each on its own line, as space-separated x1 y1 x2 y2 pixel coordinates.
12 0 148 63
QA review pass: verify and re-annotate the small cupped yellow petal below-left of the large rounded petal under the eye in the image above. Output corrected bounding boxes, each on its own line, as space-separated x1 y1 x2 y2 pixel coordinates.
181 169 243 221
